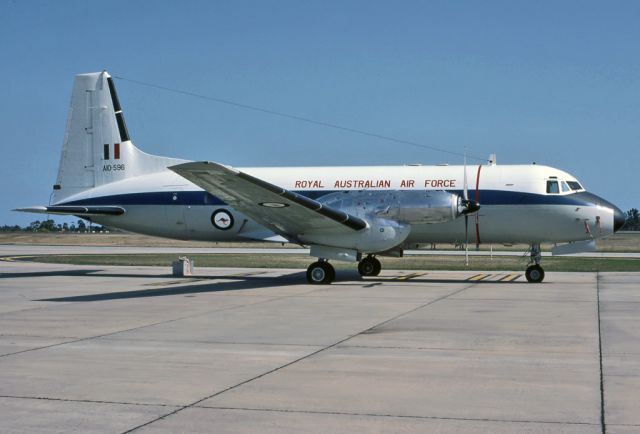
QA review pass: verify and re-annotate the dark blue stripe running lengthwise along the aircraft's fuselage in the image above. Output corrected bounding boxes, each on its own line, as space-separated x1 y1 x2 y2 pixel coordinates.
56 190 597 206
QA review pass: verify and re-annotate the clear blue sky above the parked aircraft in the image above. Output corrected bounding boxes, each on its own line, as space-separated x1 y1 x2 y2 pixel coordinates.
0 0 640 225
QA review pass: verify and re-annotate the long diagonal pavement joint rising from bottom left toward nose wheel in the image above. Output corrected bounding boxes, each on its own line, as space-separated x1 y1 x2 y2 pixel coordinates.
123 285 474 434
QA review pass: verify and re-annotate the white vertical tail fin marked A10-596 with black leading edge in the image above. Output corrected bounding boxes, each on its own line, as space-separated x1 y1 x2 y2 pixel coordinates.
52 71 182 203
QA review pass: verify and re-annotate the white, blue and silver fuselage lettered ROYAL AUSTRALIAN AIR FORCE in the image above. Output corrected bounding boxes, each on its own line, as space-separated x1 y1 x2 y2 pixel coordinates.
58 165 619 246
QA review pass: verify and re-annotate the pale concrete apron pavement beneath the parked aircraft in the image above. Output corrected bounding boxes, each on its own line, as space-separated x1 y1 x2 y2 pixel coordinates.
0 262 640 433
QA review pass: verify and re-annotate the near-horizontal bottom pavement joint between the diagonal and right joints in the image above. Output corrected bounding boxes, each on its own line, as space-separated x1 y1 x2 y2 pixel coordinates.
192 405 600 426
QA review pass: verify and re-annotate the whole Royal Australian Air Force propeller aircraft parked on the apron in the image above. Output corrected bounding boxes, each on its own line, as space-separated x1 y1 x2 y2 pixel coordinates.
18 71 625 283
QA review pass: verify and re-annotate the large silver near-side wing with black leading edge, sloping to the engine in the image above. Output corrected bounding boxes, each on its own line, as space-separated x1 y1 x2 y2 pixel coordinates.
169 161 367 240
